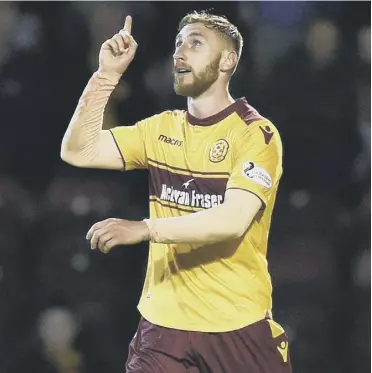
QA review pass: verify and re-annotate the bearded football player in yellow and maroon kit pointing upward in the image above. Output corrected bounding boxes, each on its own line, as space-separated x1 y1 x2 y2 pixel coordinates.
61 12 291 373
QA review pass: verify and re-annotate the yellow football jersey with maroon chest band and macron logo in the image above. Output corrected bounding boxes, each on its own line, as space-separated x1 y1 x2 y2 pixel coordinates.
111 98 282 332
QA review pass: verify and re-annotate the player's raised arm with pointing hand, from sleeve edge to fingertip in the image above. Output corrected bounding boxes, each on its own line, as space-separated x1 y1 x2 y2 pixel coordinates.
61 16 137 170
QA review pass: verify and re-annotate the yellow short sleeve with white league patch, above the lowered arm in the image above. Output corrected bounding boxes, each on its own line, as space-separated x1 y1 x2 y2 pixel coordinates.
226 121 282 206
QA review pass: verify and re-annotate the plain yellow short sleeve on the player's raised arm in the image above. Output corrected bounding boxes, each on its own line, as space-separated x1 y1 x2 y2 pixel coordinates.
110 118 151 171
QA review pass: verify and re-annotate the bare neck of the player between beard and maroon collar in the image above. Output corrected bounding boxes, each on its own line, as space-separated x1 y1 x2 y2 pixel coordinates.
187 83 235 119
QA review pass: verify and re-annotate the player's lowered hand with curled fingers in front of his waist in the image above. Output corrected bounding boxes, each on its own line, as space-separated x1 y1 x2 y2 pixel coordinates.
86 218 149 254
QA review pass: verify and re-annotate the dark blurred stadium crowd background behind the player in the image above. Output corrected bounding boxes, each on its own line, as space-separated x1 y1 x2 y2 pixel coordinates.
0 2 371 373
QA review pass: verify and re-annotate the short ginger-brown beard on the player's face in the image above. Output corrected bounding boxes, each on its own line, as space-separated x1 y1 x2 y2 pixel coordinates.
173 56 220 98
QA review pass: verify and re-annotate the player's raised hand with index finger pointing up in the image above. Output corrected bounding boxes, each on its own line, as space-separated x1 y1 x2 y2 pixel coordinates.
99 16 138 75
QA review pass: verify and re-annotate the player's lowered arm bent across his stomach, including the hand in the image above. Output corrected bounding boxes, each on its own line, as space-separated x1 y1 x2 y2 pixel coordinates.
86 189 262 253
